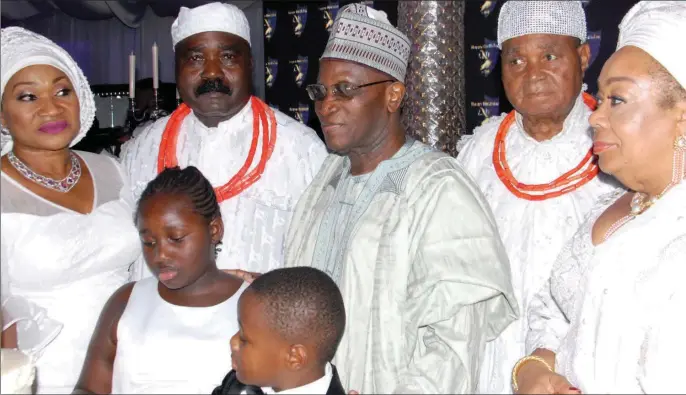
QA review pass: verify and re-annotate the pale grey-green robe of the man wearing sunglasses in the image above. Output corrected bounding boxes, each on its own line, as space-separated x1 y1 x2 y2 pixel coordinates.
286 140 517 394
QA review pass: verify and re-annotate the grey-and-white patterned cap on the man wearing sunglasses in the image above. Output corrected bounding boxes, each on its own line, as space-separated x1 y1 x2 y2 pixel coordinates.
320 3 410 82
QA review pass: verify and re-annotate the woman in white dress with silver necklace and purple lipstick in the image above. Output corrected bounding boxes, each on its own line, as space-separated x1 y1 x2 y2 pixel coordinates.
0 27 140 394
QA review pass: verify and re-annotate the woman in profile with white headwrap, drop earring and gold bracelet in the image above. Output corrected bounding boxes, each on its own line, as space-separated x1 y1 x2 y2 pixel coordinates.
512 1 686 394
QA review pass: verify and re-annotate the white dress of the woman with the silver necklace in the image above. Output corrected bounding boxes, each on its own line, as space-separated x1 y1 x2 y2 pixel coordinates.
0 152 141 394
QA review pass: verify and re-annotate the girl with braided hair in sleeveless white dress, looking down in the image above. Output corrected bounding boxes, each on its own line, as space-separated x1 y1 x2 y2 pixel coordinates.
75 166 248 394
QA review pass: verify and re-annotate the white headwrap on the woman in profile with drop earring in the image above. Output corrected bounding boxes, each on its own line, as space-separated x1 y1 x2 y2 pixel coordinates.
617 1 686 88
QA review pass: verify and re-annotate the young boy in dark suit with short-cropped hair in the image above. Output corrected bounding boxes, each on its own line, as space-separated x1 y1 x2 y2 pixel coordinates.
212 267 346 395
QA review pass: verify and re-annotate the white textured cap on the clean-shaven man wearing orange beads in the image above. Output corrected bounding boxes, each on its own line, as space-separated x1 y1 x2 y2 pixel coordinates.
498 0 586 49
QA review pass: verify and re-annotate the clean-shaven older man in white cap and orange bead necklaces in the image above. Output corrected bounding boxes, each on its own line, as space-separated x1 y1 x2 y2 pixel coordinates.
457 1 615 394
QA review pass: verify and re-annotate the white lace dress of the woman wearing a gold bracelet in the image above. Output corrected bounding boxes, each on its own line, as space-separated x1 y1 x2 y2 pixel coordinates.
527 183 686 394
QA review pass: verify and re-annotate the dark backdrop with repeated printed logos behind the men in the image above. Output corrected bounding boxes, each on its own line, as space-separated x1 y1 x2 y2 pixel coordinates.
264 0 637 141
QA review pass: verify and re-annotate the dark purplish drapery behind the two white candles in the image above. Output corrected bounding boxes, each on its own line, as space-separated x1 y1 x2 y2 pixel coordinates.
0 0 265 98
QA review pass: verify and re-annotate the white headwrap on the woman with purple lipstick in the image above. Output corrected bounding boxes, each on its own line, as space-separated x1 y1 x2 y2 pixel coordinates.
0 27 95 155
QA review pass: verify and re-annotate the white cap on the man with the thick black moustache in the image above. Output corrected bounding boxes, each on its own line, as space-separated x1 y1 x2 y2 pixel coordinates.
171 2 250 47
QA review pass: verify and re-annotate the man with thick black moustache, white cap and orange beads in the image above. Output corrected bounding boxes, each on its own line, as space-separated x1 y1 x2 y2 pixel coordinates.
123 3 326 277
